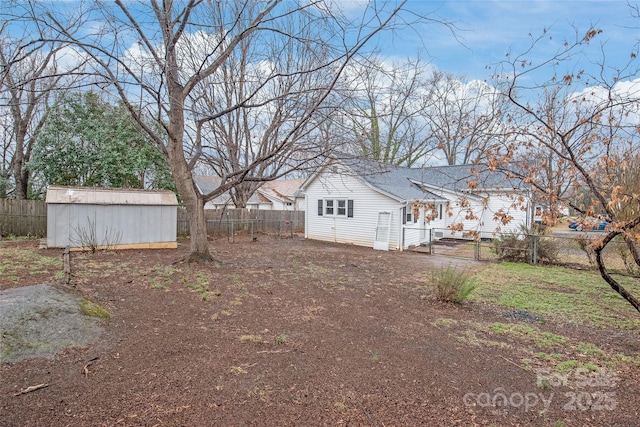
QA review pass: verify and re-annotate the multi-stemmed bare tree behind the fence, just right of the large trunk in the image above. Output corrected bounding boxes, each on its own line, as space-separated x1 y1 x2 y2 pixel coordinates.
190 4 338 207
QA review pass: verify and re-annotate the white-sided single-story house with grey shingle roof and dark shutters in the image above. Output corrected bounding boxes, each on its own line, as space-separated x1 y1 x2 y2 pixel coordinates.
300 156 532 250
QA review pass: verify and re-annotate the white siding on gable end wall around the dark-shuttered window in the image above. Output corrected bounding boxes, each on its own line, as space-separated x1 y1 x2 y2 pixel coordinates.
305 169 402 250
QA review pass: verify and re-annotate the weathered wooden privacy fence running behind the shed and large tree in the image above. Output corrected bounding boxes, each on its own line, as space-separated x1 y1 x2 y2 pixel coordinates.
0 199 304 237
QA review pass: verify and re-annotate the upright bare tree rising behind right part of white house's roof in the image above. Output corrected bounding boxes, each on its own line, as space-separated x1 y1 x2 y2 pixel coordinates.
422 71 505 165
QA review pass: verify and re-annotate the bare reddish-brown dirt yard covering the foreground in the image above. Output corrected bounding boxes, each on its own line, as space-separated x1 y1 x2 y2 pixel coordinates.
0 236 640 427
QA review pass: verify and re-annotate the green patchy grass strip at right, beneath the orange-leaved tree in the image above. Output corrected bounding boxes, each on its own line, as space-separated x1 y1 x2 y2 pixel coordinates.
471 263 640 330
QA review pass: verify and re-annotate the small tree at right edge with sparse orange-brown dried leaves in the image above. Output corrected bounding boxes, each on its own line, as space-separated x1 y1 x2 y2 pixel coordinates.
492 29 640 311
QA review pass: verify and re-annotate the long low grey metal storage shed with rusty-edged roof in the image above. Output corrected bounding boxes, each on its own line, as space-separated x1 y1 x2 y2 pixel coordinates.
46 186 178 249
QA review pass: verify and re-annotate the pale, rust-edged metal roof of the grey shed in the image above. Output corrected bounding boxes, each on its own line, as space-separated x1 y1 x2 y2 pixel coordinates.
46 186 178 206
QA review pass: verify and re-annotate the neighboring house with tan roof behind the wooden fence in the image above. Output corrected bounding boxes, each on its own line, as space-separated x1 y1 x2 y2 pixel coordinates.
193 175 304 211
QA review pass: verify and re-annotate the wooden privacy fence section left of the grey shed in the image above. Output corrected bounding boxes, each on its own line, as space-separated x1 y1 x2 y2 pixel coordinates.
0 199 47 237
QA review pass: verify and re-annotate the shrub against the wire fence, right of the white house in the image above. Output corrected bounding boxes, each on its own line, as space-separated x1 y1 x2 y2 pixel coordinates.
493 226 559 264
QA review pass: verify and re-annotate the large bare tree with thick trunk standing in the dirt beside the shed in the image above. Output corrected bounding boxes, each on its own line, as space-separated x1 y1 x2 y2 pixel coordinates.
32 0 404 261
